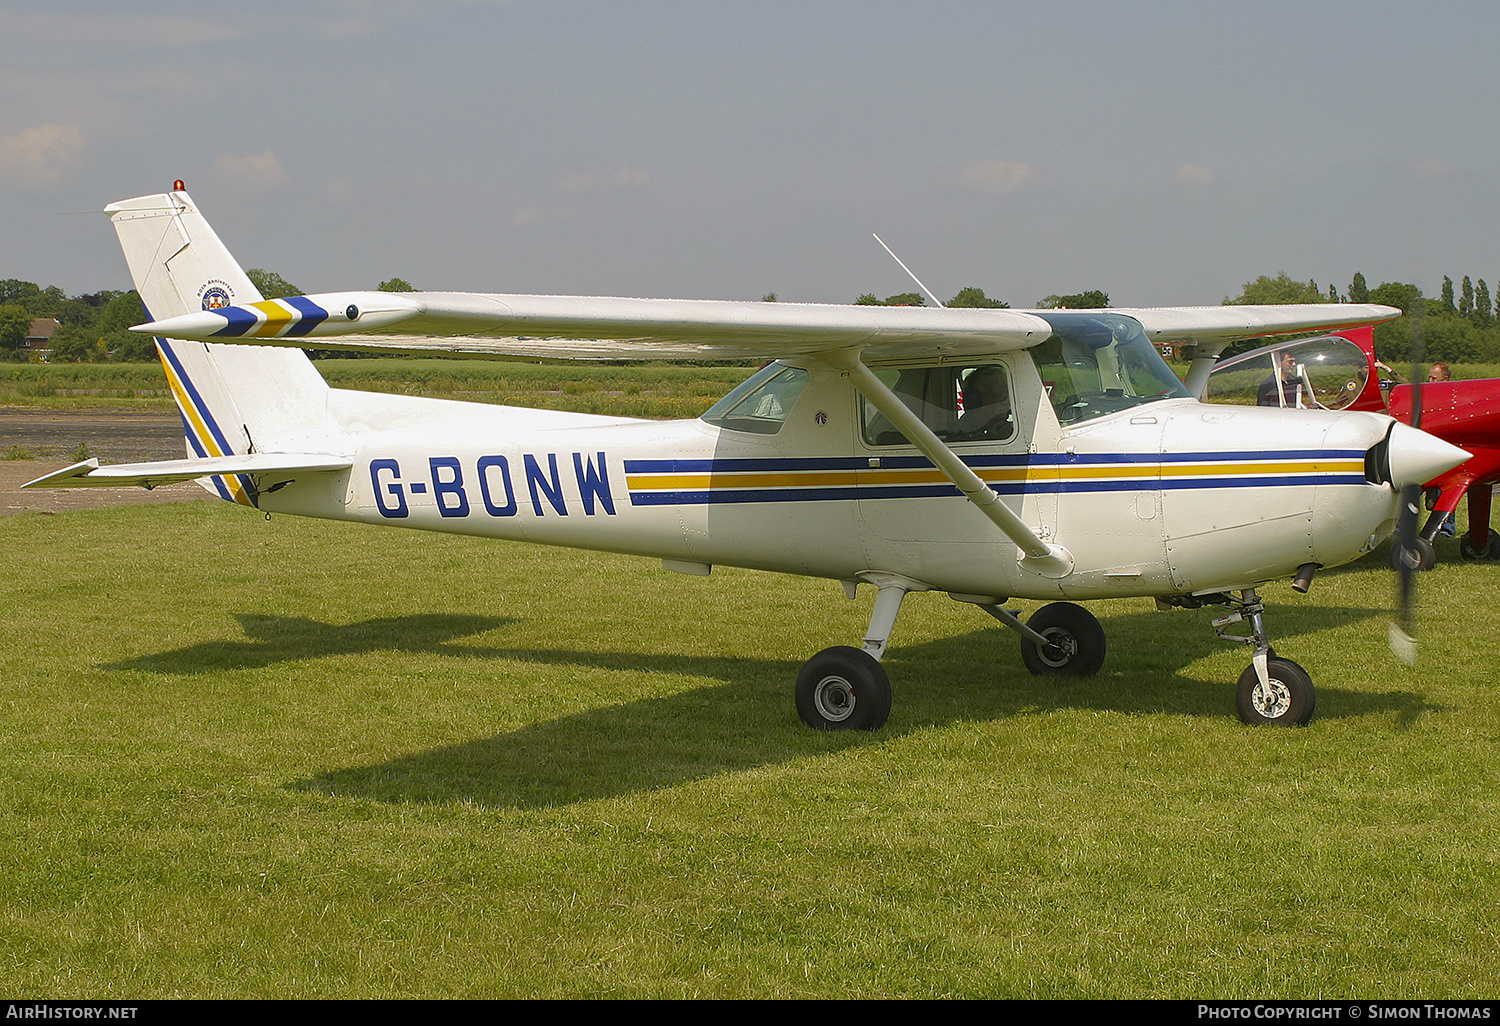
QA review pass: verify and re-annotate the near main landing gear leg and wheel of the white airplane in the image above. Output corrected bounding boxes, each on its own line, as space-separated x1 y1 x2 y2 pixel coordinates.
797 581 920 731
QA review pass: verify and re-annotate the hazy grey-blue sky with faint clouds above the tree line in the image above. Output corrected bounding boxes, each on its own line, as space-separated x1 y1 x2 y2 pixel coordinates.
0 0 1500 306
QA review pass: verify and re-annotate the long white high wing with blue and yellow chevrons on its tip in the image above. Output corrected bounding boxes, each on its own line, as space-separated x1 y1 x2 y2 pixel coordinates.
132 293 1400 360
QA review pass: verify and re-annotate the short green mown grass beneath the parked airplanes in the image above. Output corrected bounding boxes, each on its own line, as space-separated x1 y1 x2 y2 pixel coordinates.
0 504 1500 998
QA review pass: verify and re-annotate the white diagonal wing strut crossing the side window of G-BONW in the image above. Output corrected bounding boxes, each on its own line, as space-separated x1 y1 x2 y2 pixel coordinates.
818 350 1073 579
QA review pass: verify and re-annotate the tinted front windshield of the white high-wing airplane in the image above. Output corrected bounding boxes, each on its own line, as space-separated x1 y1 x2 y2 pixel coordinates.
1031 311 1190 425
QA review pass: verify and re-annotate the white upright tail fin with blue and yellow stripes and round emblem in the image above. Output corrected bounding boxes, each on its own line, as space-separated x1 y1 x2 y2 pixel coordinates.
105 192 329 506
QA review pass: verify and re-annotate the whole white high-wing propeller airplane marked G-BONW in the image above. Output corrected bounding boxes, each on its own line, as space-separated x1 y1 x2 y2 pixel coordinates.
27 183 1467 729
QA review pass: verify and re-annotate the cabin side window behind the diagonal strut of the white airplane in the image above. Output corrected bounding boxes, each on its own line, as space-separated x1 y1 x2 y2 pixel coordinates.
860 363 1016 446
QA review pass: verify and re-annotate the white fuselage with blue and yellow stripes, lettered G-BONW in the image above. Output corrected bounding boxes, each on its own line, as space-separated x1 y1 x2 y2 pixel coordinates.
257 354 1394 599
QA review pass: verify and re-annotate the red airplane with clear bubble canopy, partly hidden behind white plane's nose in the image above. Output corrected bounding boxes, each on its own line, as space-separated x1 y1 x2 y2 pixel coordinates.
1190 327 1500 570
